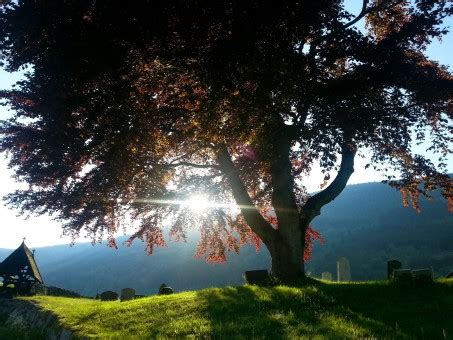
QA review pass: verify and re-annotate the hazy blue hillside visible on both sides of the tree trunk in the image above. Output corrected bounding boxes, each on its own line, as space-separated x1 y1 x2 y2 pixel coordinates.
0 183 453 296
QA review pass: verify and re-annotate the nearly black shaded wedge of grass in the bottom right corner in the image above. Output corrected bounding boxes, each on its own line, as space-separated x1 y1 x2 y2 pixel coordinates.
319 280 453 339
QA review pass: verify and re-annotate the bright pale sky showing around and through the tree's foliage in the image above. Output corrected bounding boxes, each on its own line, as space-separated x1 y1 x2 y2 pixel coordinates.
0 0 453 248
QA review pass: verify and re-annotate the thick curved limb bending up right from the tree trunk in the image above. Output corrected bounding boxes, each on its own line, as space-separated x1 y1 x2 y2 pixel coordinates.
302 145 356 223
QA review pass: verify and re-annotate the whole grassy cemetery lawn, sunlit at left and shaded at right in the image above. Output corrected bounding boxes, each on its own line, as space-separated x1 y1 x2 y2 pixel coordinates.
19 279 453 339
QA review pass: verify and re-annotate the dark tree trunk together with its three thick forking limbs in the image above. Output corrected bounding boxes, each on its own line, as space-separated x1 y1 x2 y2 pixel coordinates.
218 140 355 282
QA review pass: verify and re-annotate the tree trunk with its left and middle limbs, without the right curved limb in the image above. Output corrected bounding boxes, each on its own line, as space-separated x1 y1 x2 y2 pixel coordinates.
218 143 305 282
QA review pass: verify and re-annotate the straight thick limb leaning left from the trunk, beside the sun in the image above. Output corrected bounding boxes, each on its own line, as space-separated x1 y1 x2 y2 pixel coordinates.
217 145 276 243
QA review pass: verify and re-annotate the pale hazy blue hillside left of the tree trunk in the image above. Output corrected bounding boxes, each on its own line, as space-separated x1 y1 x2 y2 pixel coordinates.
0 238 269 296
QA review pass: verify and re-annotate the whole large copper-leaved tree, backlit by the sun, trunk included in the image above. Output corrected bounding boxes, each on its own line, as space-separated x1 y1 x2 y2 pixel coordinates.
0 0 453 280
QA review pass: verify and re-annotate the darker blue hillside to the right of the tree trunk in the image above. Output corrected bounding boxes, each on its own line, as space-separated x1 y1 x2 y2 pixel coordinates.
307 183 453 280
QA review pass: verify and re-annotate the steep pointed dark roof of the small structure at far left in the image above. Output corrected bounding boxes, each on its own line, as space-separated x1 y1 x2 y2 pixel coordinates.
0 242 43 283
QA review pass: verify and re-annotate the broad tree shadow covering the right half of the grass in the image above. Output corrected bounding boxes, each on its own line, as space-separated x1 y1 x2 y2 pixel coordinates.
198 283 453 339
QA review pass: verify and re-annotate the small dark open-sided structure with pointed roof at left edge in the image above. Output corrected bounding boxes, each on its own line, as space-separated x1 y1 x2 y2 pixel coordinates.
0 240 44 295
